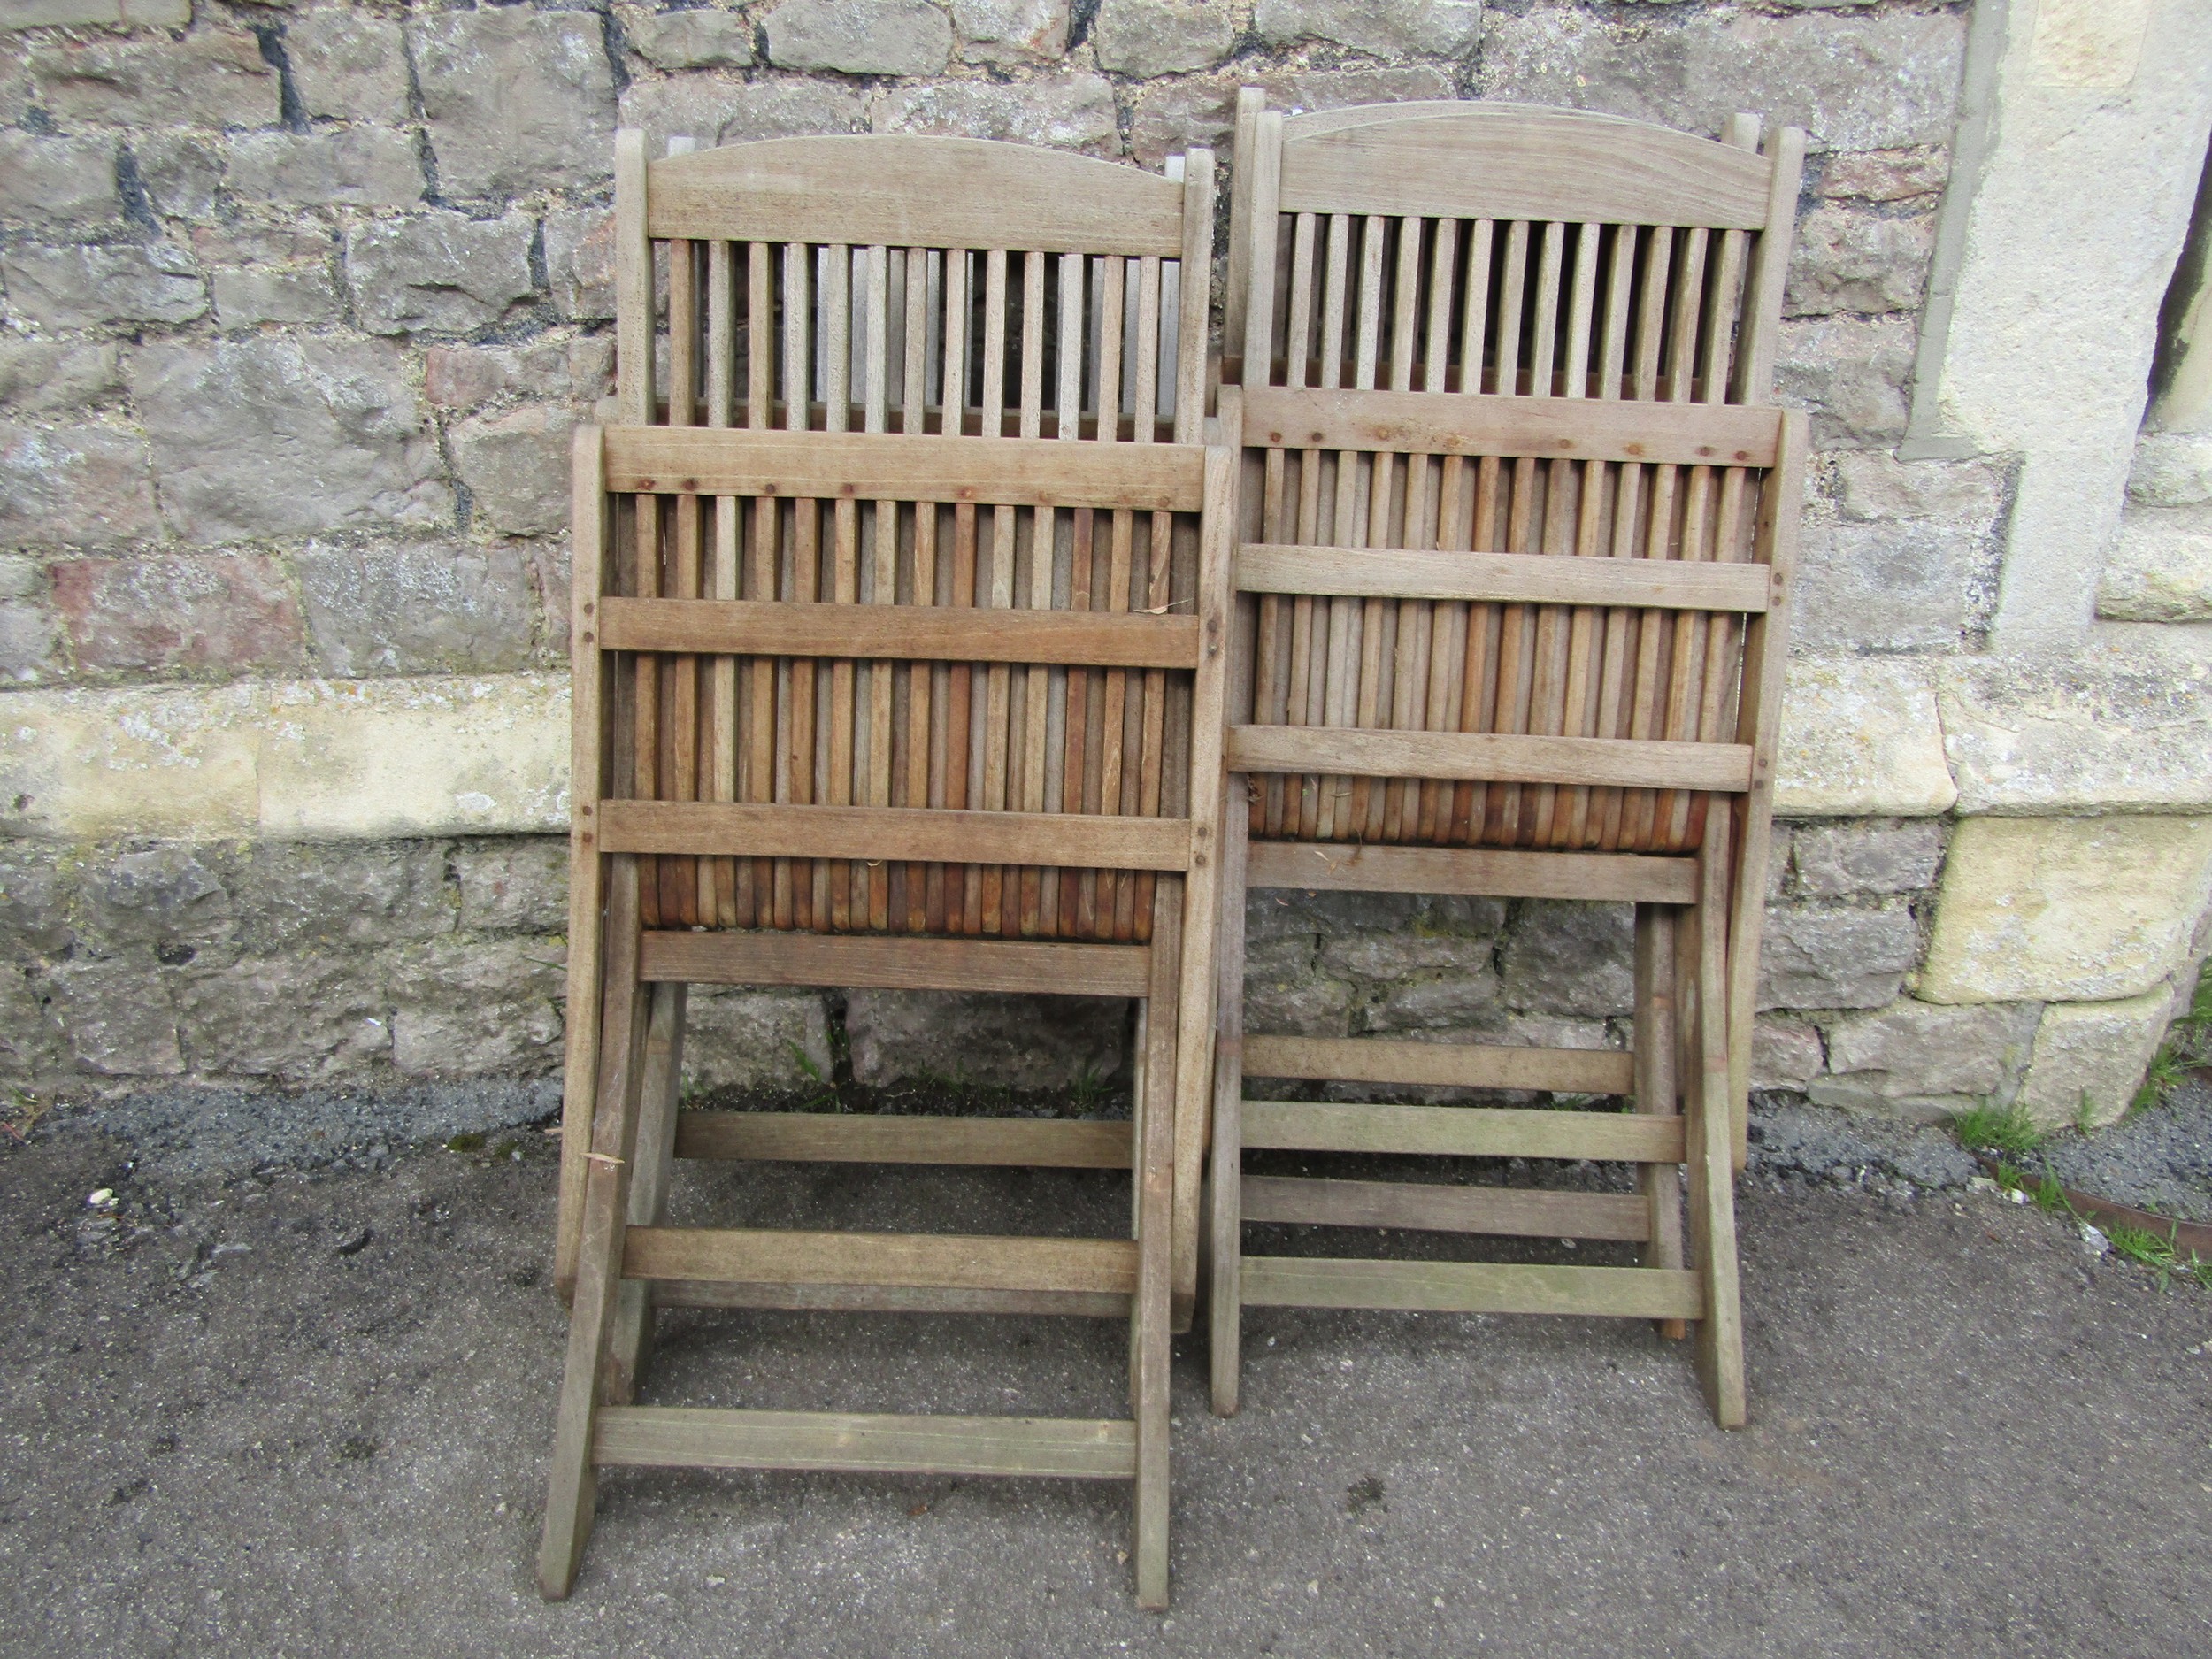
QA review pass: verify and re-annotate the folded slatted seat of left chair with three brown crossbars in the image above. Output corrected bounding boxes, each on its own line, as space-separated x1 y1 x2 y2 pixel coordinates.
573 427 1230 942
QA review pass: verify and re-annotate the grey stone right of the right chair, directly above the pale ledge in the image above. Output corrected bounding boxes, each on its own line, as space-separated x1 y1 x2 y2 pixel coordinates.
1790 520 2000 653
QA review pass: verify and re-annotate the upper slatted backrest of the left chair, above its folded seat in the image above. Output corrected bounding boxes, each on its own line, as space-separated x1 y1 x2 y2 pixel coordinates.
615 131 1215 442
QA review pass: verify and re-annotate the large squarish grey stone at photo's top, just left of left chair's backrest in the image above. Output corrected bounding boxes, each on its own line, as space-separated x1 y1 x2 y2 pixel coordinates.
414 7 615 199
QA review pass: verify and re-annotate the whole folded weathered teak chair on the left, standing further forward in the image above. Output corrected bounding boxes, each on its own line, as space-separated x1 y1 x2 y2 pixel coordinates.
540 133 1234 1606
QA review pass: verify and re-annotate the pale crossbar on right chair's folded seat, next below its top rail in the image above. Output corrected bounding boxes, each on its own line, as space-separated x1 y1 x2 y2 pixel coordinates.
1237 542 1774 615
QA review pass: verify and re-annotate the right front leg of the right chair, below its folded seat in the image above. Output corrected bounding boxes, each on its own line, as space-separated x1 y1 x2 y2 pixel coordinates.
1684 818 1747 1429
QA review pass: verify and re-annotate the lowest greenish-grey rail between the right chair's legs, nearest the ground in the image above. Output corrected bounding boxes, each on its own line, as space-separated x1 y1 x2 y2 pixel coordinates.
1243 1256 1706 1318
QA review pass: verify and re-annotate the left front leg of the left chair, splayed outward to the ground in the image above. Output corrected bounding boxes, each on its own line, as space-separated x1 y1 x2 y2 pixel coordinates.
538 858 644 1601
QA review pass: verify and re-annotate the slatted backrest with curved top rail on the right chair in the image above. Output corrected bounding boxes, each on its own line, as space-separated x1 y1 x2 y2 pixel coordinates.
1224 91 1805 403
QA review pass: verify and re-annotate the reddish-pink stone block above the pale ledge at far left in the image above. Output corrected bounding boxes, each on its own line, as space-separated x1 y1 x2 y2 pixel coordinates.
53 553 301 675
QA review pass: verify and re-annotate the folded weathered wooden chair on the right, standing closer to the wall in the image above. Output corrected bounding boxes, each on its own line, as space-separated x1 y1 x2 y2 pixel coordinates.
1208 91 1805 1427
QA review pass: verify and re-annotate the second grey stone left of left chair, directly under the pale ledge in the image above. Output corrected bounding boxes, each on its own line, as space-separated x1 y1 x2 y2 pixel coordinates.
215 839 454 958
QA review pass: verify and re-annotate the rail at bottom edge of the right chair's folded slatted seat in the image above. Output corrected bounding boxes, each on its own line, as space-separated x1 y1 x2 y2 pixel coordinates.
1246 841 1697 905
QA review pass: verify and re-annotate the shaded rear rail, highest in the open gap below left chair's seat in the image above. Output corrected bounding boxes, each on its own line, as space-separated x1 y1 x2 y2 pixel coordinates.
677 1113 1131 1171
